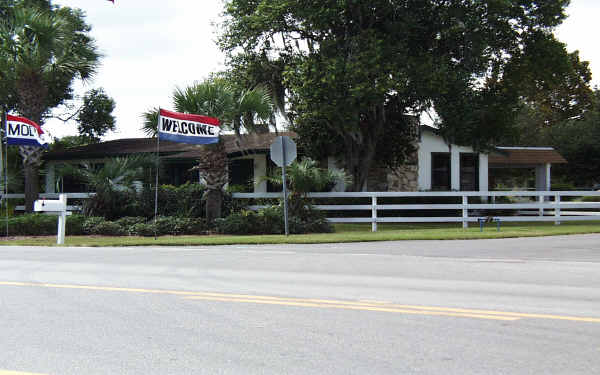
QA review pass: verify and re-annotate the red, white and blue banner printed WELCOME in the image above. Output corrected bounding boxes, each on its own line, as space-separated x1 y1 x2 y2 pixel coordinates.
158 109 221 145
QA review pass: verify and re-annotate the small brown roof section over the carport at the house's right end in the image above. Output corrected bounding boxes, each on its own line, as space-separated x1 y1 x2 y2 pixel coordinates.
489 147 567 165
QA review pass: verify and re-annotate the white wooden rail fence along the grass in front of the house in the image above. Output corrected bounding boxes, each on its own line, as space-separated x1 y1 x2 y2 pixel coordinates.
233 191 600 232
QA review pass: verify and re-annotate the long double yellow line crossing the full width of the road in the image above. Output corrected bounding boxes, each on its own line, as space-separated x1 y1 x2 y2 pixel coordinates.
0 281 600 324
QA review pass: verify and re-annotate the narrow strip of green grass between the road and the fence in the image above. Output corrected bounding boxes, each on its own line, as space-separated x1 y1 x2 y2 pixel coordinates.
0 221 600 246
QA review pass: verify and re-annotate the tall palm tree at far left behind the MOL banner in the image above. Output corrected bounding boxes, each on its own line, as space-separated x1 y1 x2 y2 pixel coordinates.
0 2 100 211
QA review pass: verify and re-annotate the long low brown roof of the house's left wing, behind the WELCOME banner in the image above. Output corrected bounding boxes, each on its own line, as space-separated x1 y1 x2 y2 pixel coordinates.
44 132 297 160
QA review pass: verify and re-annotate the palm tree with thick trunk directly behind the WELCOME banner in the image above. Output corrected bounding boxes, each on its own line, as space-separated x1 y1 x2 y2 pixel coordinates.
173 79 273 221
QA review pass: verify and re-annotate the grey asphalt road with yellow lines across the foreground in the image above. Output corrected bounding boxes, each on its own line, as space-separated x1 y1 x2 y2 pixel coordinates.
0 235 600 375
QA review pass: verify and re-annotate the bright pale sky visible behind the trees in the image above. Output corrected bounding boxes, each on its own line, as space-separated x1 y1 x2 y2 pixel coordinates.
44 0 600 139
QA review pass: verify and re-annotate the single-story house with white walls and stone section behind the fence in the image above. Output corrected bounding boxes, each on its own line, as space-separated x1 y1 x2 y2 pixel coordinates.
44 126 566 192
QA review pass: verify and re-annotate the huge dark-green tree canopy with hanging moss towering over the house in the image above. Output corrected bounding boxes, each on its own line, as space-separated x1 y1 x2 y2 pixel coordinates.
219 0 590 190
